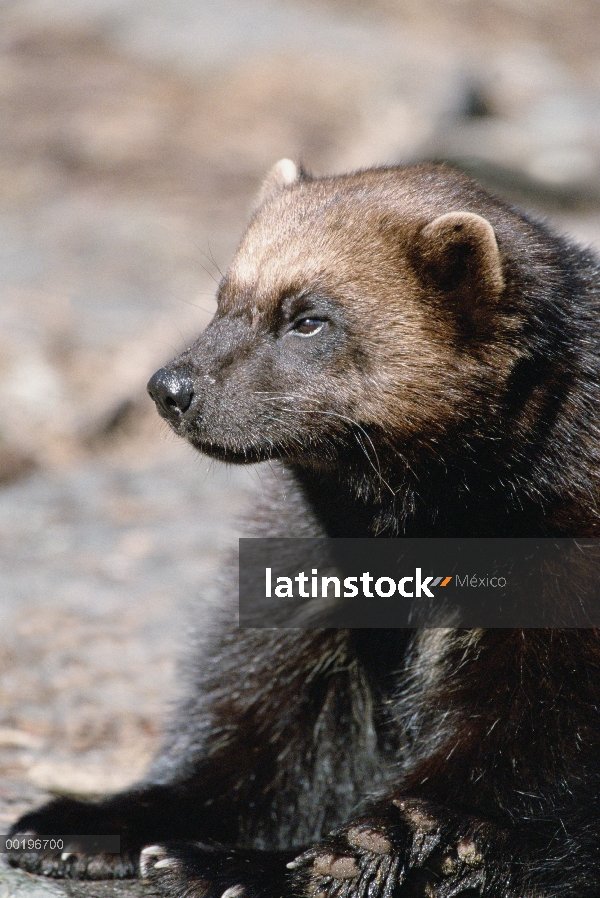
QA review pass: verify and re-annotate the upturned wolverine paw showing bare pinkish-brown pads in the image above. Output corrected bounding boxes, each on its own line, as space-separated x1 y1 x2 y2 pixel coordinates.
288 799 486 898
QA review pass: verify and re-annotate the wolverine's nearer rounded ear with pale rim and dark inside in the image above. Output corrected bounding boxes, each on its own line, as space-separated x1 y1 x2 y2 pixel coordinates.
417 212 504 301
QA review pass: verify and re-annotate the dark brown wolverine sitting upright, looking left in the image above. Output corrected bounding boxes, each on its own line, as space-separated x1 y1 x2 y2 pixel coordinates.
11 160 600 898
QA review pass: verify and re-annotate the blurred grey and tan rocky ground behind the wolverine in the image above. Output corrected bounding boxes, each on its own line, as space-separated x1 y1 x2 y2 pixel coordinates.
0 0 600 896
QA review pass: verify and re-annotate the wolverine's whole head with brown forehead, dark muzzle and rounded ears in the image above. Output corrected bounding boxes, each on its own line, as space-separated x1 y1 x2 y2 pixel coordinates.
148 163 528 465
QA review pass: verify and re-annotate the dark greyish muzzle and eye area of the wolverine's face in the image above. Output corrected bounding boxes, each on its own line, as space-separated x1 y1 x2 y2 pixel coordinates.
148 264 380 463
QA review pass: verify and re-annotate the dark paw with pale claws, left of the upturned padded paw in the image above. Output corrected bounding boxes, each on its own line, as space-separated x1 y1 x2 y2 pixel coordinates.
140 842 293 898
